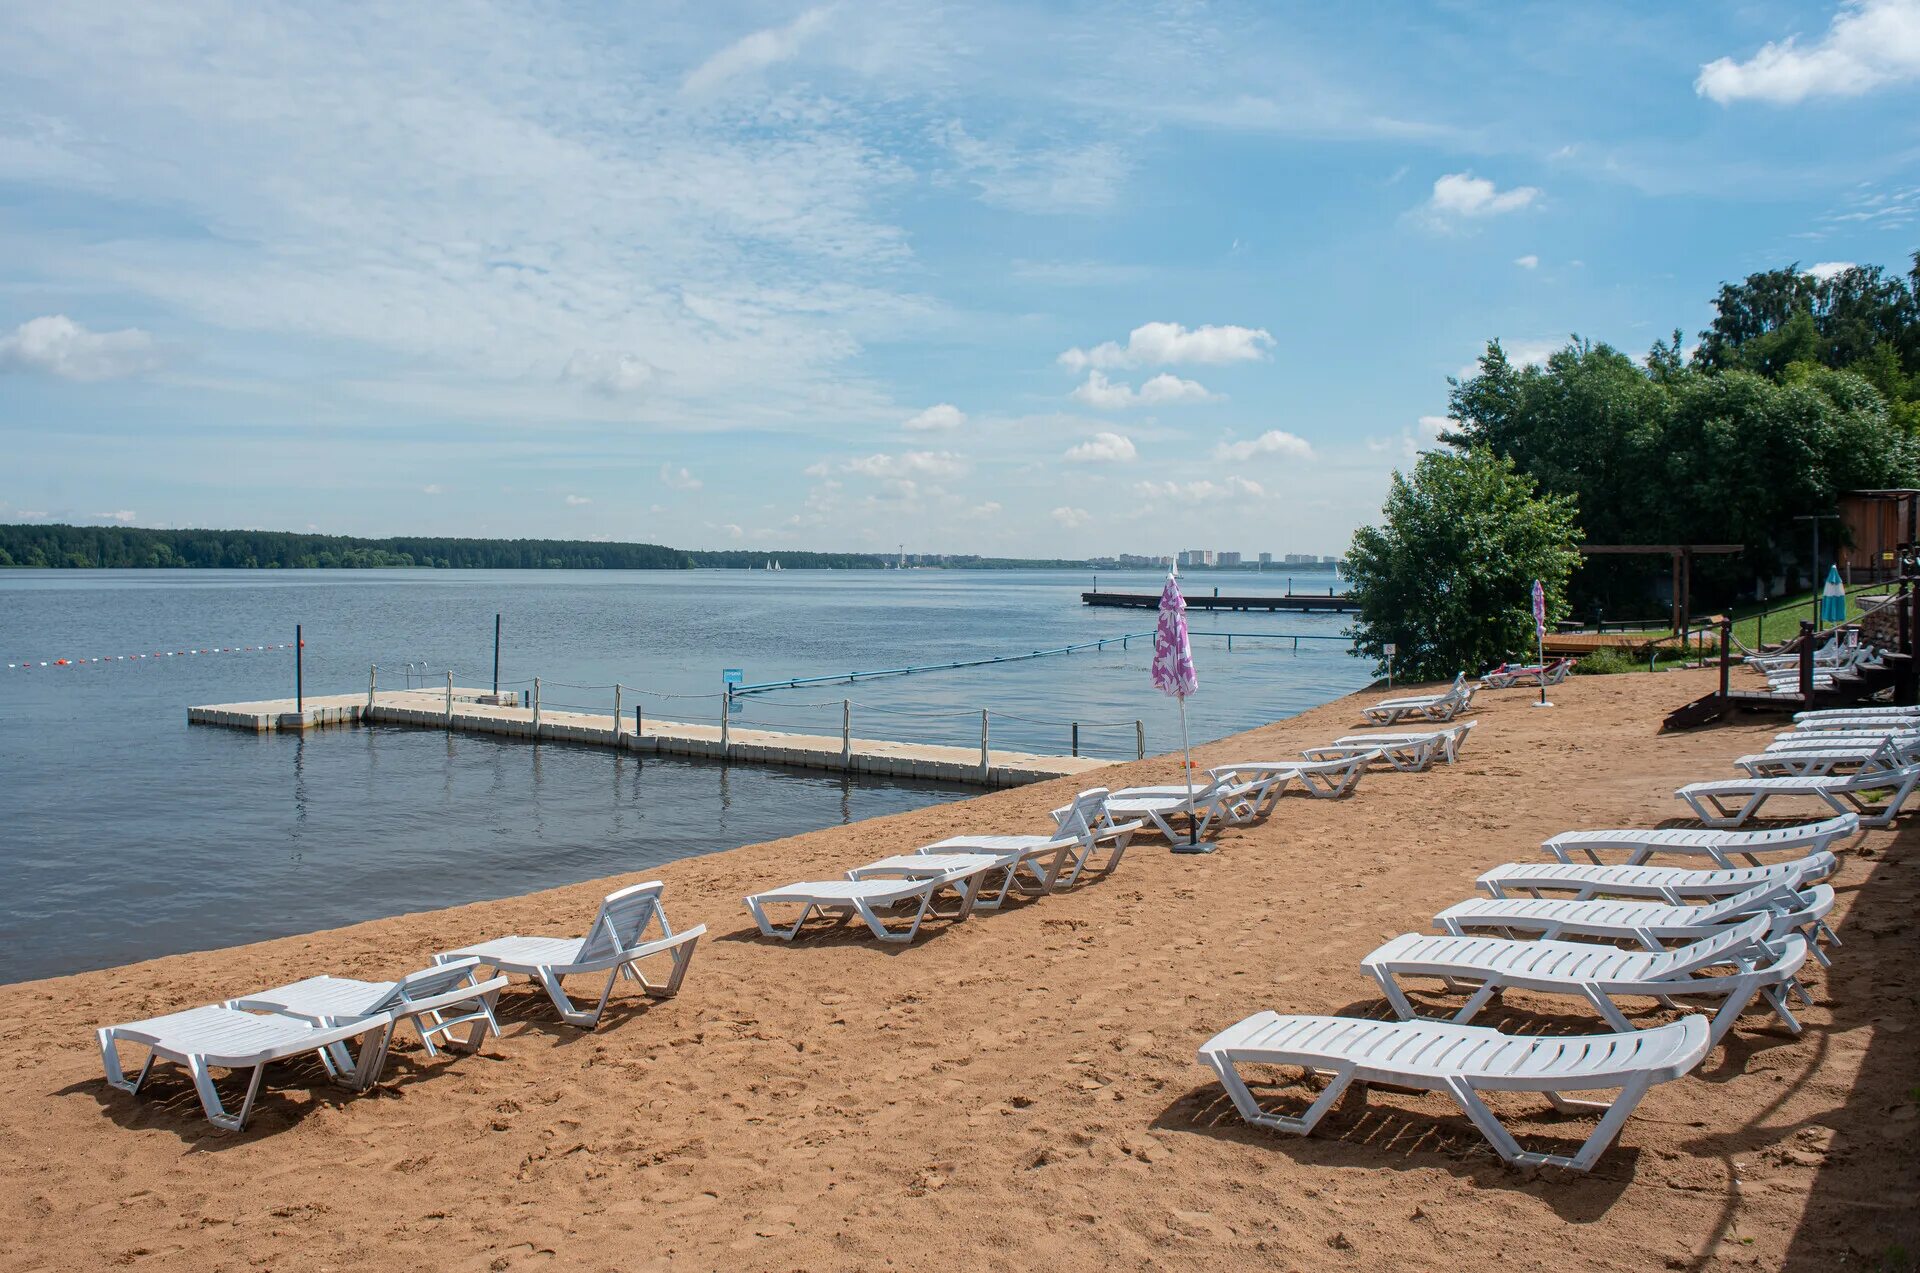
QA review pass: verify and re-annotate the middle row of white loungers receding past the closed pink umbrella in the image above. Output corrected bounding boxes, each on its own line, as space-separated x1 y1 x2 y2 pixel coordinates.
743 720 1475 943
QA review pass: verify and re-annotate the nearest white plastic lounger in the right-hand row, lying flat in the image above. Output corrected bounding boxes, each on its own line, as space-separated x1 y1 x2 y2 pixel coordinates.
1200 1012 1713 1171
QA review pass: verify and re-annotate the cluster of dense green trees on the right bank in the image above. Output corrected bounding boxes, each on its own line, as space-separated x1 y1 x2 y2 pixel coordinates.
1346 252 1920 680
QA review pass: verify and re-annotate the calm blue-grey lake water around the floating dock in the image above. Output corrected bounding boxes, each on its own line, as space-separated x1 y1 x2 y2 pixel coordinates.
0 570 1369 981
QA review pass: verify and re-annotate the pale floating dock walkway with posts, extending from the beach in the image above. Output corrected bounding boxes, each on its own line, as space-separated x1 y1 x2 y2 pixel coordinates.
186 687 1114 787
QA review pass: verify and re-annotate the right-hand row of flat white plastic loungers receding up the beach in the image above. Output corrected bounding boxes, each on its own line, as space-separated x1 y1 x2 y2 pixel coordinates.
1198 709 1920 1171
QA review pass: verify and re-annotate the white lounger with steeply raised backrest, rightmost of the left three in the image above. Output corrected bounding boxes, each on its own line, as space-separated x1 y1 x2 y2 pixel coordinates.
434 879 707 1029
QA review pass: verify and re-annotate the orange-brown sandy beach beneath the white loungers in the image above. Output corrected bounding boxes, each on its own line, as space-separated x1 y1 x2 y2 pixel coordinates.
0 672 1920 1269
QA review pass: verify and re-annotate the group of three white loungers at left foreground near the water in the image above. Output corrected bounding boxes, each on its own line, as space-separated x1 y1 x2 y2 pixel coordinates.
98 881 707 1131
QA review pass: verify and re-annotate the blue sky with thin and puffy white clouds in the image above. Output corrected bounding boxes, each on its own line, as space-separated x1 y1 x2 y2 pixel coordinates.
0 0 1920 557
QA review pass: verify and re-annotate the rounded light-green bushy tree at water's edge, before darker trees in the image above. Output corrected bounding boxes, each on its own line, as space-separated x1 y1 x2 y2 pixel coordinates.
1344 449 1580 680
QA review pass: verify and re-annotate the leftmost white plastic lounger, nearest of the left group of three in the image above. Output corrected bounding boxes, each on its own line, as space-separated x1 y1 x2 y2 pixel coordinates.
98 1004 394 1131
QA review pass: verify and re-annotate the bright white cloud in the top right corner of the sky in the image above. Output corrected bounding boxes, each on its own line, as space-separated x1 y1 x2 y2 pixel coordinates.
1693 0 1920 106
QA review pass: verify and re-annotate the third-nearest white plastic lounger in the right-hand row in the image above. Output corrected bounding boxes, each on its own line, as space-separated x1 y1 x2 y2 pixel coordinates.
1434 883 1834 964
